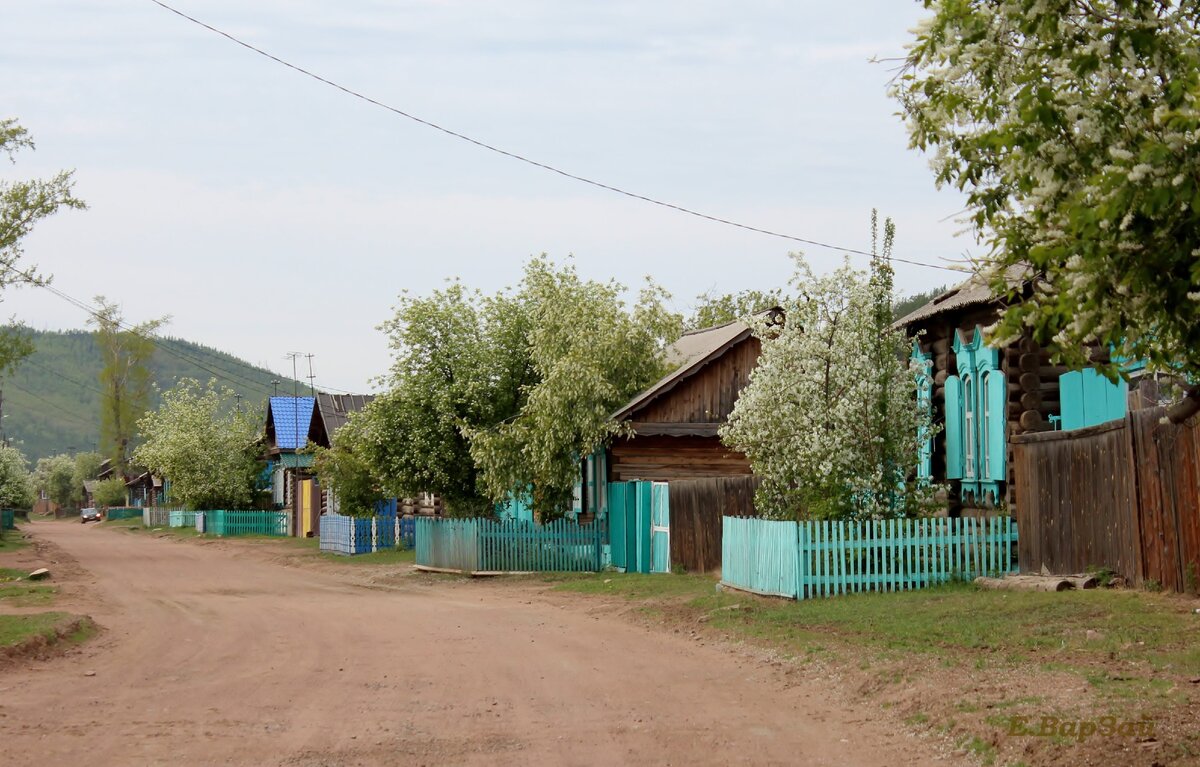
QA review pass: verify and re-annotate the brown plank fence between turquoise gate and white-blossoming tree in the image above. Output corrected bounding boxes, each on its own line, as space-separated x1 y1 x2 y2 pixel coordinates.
670 477 762 573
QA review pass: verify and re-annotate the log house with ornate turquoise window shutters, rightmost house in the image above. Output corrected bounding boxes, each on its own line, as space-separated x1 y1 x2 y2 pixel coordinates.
895 268 1138 515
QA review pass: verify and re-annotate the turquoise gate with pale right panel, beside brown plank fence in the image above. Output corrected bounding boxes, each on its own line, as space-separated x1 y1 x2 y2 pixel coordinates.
608 481 671 573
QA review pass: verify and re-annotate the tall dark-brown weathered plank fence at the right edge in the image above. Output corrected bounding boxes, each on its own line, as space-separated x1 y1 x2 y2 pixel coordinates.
1012 407 1200 592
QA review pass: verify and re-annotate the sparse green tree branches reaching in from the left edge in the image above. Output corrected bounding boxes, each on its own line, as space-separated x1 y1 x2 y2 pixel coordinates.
0 118 86 376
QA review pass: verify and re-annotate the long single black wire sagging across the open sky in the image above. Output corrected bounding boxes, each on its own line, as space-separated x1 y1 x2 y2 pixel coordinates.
150 0 962 271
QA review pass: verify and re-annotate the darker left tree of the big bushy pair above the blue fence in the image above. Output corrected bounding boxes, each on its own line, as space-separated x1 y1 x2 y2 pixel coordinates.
352 281 535 515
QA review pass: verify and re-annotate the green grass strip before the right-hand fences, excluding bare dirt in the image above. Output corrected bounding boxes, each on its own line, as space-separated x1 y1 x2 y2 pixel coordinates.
549 573 1200 681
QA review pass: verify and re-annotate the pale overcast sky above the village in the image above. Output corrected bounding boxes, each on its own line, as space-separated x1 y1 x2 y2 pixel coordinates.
0 0 972 391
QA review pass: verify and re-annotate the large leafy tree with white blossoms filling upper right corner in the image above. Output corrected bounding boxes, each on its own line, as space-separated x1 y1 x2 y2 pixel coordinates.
894 0 1200 420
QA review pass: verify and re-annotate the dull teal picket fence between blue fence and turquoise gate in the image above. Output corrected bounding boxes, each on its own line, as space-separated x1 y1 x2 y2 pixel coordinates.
416 517 605 573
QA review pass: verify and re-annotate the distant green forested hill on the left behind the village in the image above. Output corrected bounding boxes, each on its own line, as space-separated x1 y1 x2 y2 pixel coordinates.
0 330 302 466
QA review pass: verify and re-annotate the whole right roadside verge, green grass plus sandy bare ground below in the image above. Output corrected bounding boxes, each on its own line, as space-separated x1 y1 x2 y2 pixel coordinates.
542 574 1200 767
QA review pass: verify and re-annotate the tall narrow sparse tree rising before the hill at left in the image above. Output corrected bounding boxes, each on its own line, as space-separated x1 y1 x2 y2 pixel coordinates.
88 295 168 475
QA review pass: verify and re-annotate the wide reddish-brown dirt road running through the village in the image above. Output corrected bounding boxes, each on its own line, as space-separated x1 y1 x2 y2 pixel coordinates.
0 521 955 767
